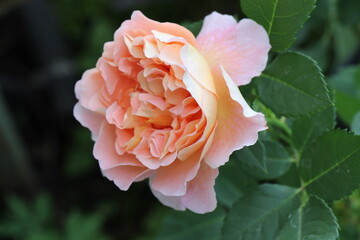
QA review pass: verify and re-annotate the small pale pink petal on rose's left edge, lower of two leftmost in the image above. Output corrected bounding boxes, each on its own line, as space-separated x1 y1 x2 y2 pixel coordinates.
74 102 104 141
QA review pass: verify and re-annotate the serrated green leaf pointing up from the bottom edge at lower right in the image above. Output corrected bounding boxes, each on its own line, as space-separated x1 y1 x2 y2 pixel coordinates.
276 197 339 240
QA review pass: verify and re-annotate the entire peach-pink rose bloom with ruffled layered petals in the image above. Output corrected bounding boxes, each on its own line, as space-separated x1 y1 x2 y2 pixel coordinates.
74 11 270 213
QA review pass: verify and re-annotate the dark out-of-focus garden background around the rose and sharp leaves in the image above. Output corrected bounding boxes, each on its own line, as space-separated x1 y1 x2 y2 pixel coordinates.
0 0 360 240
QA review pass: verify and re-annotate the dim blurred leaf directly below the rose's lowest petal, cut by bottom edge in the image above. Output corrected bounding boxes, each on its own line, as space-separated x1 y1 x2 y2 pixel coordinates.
156 208 225 240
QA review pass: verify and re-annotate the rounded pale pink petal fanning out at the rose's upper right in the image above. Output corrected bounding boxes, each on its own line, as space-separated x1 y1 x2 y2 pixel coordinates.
196 12 271 85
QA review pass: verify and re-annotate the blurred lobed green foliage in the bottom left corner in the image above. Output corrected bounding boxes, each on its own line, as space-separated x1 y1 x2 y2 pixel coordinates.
0 194 111 240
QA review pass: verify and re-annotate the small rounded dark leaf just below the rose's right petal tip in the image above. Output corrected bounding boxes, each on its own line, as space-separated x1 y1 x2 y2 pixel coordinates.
238 140 291 179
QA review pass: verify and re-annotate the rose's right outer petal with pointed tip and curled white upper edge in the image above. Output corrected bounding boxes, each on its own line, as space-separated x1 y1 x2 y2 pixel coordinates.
205 67 267 168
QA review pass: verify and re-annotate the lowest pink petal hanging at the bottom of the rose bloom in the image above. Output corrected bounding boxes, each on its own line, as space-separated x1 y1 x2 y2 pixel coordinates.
151 164 219 213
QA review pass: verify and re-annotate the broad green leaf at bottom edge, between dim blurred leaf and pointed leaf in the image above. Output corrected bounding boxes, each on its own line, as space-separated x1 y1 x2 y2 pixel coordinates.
223 184 300 240
